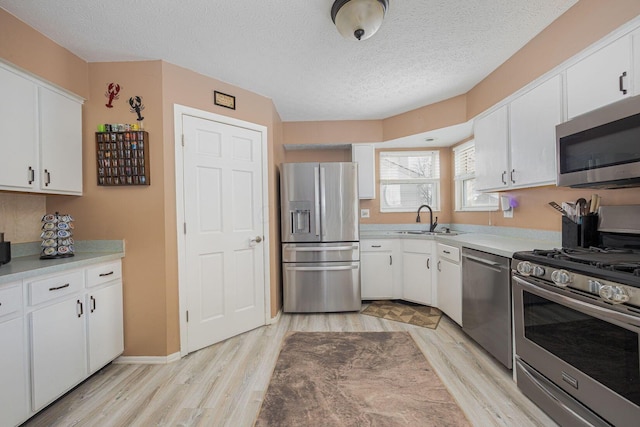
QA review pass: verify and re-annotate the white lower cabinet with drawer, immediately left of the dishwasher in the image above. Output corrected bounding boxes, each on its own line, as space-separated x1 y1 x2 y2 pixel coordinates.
437 243 462 326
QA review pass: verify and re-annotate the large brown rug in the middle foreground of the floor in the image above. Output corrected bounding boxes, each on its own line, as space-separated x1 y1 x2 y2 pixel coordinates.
255 332 470 427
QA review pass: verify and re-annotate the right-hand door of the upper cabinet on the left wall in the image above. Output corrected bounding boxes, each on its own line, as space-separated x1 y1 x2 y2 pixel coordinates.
38 87 82 194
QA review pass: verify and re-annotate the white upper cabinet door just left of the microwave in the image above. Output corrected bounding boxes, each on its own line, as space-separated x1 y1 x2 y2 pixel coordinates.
508 75 562 187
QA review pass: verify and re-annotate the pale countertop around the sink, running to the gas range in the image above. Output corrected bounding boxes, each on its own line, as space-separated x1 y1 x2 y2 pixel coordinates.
360 230 561 258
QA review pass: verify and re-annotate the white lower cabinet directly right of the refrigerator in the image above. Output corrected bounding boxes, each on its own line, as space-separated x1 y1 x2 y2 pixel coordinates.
360 239 401 300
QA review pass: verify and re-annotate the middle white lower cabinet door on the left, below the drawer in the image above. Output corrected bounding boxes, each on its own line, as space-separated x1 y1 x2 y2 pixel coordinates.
31 295 87 411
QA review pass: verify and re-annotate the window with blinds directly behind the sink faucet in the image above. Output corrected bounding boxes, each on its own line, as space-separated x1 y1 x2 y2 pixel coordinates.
380 151 440 212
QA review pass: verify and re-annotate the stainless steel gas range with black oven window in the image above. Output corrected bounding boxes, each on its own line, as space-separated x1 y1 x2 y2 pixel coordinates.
512 206 640 426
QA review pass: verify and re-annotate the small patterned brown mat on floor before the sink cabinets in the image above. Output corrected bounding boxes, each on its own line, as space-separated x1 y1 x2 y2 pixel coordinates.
361 301 442 329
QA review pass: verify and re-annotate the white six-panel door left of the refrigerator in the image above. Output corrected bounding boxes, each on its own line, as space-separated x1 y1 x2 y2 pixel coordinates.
183 115 265 351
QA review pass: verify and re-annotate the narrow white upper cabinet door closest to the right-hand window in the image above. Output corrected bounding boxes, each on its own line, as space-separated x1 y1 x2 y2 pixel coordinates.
474 105 509 190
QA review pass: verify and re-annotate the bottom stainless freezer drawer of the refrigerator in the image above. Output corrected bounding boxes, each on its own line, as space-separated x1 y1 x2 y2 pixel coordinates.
283 262 362 313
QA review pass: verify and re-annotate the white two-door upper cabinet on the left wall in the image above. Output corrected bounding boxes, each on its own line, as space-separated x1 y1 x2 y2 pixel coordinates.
0 62 82 195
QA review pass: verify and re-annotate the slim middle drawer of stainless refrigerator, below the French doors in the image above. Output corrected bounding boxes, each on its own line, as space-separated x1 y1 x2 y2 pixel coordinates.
282 242 360 262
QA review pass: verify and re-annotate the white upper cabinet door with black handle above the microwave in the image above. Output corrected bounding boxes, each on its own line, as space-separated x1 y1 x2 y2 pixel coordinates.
567 35 633 119
